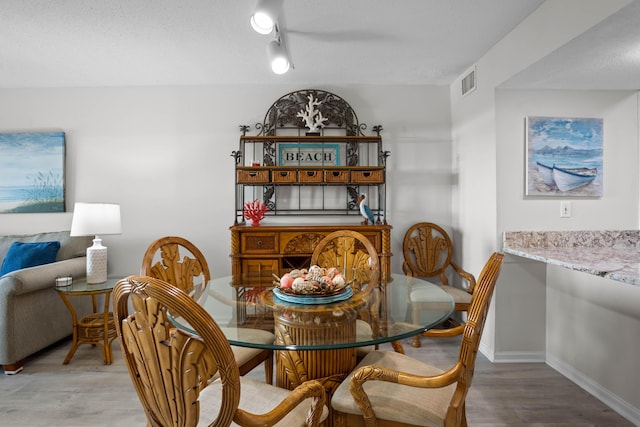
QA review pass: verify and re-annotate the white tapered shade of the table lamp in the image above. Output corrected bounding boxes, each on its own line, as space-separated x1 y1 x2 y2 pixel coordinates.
70 202 122 236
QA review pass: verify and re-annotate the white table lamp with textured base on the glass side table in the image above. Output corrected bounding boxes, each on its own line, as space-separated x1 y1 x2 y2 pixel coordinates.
70 202 122 283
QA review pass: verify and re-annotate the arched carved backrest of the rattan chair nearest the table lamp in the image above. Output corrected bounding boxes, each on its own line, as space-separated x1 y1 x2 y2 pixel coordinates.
140 236 211 293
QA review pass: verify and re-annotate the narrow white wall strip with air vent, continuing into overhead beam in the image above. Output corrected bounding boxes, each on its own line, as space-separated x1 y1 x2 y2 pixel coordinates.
450 0 637 358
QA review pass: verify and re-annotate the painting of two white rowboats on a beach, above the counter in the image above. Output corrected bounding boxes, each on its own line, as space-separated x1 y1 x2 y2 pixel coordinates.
526 117 603 198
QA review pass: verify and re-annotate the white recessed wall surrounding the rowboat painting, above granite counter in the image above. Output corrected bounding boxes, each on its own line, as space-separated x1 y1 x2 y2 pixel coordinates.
496 90 640 232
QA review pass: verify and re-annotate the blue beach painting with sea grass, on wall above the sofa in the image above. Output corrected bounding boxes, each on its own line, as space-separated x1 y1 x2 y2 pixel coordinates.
0 132 65 213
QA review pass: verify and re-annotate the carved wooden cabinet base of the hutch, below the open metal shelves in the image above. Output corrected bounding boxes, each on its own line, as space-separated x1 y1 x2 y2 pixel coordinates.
230 224 391 280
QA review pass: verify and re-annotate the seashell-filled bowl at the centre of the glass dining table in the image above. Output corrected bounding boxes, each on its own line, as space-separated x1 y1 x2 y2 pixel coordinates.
273 265 348 296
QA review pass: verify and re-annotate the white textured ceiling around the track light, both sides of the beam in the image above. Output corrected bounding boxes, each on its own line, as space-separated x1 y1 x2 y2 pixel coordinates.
0 0 640 89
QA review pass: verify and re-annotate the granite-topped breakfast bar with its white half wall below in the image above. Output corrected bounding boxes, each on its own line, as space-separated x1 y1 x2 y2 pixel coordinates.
496 230 640 425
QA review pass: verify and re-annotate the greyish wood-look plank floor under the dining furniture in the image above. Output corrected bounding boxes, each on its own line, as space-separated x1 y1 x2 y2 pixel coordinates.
0 339 633 427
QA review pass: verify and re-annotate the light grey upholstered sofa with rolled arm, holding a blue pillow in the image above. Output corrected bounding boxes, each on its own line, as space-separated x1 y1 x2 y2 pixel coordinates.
0 231 92 374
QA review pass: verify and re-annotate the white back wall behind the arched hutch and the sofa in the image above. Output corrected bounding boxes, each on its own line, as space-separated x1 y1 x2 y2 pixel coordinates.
0 85 455 276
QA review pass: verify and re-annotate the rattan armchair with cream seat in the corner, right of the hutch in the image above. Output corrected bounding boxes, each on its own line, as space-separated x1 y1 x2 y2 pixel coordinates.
402 222 476 347
